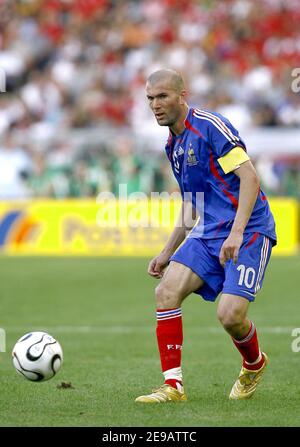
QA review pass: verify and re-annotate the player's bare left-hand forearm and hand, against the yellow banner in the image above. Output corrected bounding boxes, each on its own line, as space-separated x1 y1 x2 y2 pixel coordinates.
148 201 196 279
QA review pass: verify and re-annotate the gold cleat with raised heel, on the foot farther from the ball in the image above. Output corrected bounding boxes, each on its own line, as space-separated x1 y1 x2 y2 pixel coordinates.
229 352 269 400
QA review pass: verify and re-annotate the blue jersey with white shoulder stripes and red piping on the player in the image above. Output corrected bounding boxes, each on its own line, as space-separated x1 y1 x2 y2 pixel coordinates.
166 108 276 245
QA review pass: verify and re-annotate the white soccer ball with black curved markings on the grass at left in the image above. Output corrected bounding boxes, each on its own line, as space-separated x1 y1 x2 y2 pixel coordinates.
12 332 63 382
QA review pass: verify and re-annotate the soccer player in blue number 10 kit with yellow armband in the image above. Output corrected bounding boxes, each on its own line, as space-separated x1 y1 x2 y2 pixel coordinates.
136 69 276 403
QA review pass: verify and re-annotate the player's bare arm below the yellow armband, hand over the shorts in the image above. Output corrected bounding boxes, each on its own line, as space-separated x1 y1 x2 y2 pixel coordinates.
220 157 260 266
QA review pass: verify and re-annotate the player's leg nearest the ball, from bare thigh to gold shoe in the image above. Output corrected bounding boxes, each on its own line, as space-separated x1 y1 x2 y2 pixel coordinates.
136 261 204 403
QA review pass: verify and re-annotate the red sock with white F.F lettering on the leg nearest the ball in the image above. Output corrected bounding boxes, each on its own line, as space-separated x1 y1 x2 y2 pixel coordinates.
156 308 183 388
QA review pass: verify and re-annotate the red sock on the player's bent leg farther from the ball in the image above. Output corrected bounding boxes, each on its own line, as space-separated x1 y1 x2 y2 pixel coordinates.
232 321 265 370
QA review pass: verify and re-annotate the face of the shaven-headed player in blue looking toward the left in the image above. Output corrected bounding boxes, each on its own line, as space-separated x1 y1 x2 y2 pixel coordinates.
146 81 184 126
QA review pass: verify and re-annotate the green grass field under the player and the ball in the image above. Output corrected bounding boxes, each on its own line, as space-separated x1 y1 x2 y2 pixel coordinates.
0 257 300 427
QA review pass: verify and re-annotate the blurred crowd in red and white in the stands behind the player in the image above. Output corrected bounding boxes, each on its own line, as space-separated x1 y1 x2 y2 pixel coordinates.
0 0 300 198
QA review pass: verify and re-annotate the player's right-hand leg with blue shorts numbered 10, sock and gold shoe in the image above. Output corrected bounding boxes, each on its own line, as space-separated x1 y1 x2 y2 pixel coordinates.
218 233 271 399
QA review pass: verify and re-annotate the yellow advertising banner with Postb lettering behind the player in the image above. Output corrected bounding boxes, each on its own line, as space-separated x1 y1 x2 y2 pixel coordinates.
0 199 299 256
